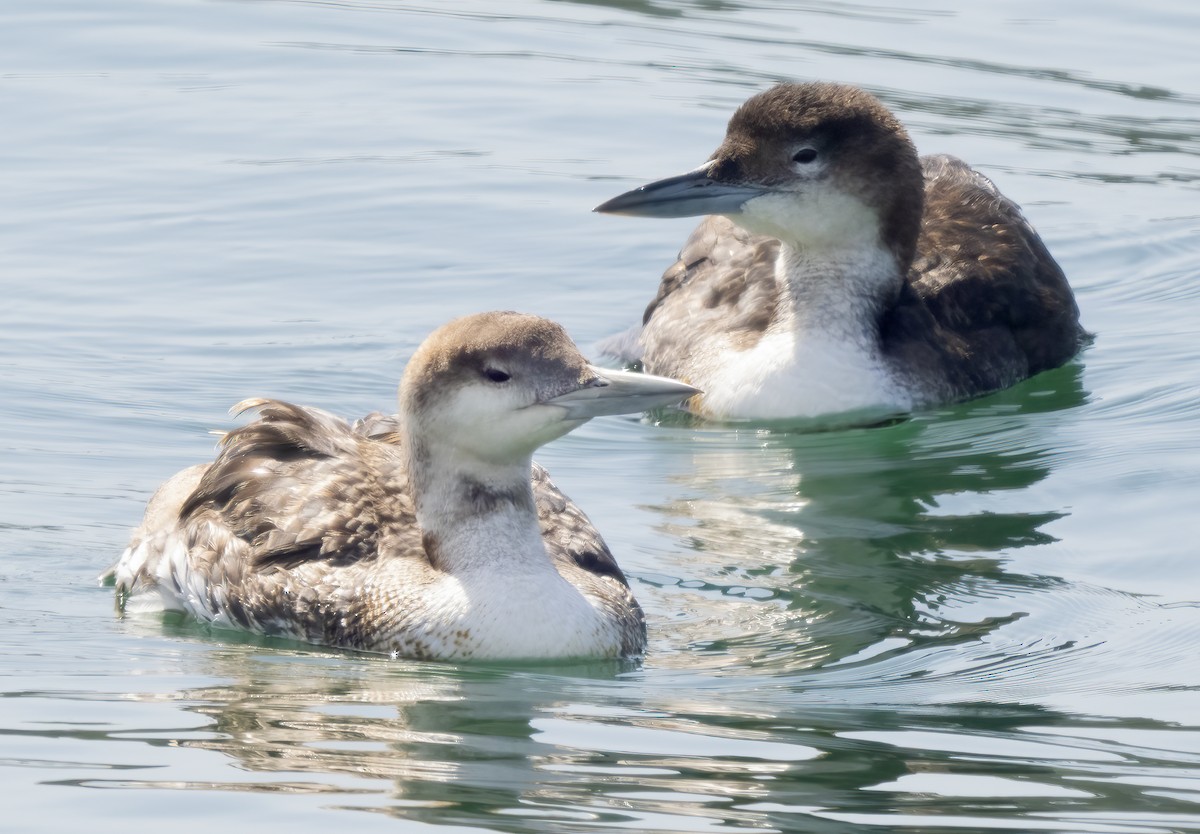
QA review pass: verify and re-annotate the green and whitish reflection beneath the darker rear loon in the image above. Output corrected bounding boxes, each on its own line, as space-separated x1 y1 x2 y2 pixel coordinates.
648 365 1086 671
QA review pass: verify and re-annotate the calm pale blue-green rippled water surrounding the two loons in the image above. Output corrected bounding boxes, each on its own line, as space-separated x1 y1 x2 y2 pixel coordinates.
0 0 1200 834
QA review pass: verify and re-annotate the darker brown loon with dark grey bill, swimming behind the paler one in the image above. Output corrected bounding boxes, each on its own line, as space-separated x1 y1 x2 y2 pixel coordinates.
595 83 1087 420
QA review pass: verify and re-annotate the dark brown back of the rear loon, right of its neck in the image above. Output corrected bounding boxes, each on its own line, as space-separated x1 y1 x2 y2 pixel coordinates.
880 156 1087 400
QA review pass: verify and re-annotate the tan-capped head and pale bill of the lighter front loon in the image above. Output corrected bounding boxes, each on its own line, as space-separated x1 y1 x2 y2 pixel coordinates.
400 312 698 466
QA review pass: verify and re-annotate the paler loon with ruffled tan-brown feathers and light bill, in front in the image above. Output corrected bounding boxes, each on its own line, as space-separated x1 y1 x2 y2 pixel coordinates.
110 312 696 659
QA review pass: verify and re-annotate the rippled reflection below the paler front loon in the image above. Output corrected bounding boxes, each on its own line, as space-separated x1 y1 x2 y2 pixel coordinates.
154 647 820 832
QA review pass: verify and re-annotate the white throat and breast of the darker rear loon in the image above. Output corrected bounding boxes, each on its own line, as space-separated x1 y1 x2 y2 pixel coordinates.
691 193 912 420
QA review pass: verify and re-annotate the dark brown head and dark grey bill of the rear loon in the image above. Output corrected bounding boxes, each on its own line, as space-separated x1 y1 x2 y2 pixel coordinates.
595 83 924 270
